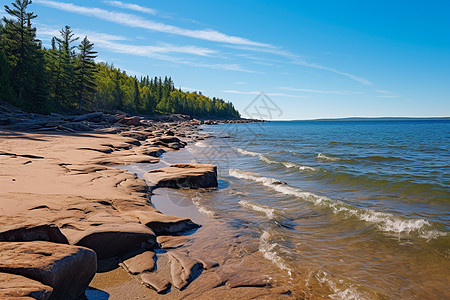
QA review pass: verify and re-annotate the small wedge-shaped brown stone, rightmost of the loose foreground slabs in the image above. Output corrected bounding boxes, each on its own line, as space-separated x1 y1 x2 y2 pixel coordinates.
169 251 203 290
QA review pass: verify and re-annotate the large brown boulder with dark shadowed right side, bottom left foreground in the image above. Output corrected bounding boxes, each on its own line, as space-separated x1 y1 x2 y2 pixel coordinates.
0 241 97 299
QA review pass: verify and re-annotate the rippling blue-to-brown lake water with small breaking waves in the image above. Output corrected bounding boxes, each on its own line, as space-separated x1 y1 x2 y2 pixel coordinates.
124 121 450 299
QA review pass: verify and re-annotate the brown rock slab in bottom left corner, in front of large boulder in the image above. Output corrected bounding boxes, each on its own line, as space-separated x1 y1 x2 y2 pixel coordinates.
0 273 53 300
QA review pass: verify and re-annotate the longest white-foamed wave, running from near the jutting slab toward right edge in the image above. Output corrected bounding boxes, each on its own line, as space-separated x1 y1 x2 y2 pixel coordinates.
229 169 447 239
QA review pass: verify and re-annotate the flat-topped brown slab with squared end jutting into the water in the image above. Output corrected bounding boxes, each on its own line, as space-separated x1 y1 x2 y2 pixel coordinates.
144 163 217 189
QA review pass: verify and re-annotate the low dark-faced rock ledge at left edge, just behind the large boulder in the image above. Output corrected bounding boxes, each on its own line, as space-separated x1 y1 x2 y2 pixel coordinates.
0 223 68 244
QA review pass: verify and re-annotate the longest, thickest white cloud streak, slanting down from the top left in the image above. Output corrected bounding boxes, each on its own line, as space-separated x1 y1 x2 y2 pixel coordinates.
35 0 273 48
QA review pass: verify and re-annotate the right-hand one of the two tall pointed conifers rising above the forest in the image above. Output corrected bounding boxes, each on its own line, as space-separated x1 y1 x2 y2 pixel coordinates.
75 36 97 111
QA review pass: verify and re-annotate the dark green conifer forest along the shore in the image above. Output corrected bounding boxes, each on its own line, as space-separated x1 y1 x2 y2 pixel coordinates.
0 0 240 118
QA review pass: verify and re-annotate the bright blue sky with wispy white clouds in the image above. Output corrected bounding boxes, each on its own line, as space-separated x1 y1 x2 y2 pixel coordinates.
0 0 450 120
